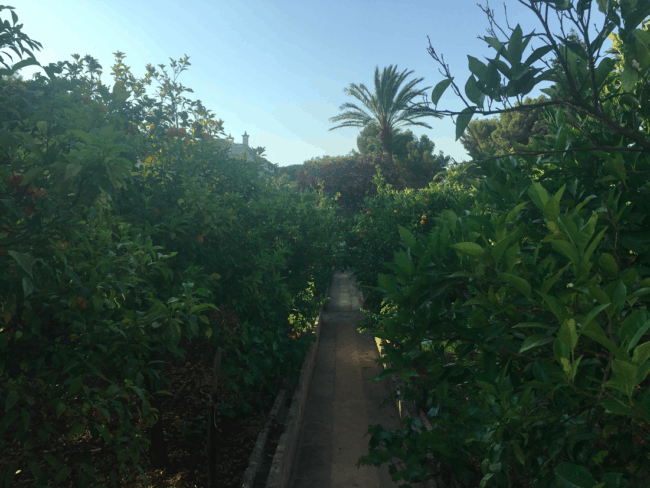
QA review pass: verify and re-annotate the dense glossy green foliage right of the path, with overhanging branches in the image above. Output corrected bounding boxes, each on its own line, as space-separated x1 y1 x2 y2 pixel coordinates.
336 0 650 488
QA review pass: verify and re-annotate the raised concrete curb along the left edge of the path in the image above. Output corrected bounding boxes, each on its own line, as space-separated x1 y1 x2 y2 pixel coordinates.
266 283 331 488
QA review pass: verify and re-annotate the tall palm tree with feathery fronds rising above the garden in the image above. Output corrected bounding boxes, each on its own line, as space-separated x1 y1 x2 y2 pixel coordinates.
329 65 441 154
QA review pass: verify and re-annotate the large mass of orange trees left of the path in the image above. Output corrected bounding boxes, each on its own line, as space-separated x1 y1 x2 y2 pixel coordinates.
0 8 340 487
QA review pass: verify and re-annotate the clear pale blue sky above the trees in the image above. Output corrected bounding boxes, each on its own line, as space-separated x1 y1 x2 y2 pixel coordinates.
11 0 608 166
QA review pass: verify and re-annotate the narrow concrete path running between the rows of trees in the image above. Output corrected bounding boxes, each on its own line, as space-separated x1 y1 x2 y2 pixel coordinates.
289 272 400 488
